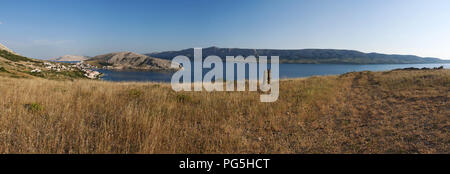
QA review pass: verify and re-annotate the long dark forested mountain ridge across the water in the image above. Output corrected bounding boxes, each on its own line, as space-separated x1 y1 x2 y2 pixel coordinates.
145 47 450 64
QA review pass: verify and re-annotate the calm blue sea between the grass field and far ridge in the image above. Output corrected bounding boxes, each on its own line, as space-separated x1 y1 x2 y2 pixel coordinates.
98 64 450 82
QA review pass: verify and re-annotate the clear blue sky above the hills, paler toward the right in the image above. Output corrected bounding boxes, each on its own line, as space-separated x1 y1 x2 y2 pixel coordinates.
0 0 450 59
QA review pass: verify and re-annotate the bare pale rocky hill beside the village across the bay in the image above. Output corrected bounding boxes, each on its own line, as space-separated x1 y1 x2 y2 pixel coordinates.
85 52 179 70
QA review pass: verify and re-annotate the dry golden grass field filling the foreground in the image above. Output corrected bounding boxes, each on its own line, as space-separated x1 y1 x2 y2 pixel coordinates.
0 70 450 153
